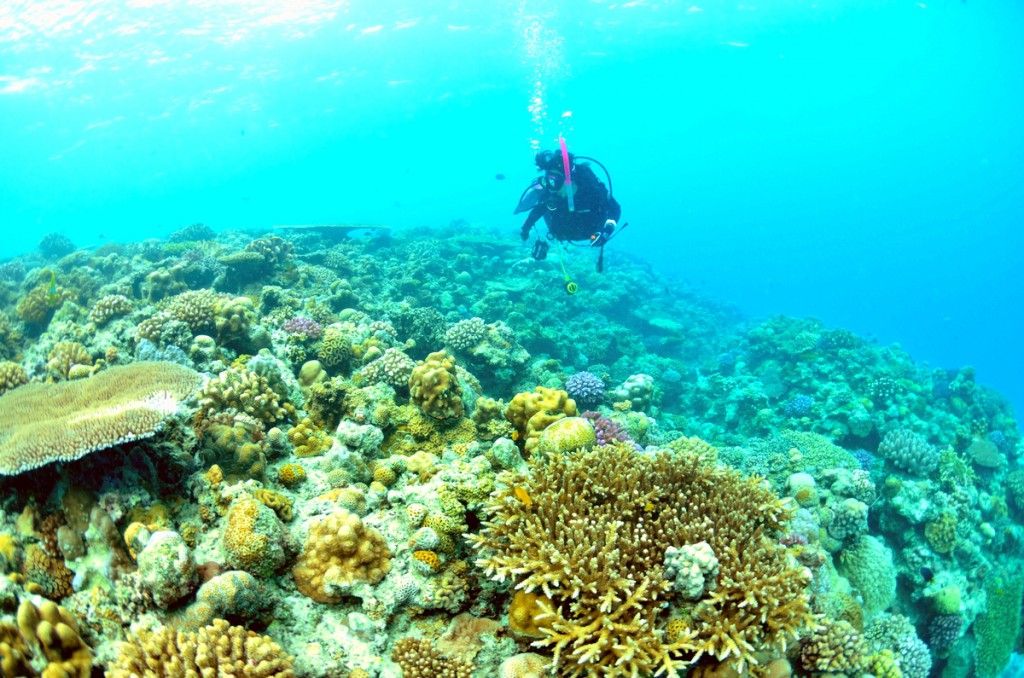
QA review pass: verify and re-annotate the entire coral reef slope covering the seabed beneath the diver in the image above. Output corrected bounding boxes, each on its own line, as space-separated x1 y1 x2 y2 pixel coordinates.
0 224 1024 678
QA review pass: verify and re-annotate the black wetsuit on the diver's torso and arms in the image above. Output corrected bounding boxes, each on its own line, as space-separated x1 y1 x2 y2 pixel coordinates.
522 163 623 241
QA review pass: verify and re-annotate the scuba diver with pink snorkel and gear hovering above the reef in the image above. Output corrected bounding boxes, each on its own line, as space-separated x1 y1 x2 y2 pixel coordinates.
514 145 625 271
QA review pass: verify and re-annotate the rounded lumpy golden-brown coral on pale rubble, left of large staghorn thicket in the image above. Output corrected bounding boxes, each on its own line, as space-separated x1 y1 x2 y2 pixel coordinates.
292 509 391 603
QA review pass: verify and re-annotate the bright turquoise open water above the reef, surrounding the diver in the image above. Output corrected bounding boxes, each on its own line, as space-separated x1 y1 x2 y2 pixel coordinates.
0 0 1024 412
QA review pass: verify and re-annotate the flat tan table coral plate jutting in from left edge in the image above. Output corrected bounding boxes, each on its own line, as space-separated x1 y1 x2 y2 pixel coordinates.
0 363 202 475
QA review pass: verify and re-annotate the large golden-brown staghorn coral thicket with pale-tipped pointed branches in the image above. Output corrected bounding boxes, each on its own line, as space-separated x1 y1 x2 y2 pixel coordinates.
469 444 812 676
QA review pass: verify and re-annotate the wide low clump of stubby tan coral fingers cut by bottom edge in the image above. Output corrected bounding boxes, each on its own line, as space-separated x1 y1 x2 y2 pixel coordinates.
108 620 295 678
